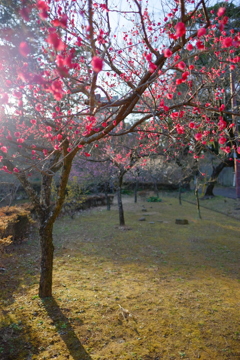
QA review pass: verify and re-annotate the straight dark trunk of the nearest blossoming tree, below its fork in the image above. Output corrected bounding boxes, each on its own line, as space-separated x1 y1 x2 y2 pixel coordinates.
39 223 54 298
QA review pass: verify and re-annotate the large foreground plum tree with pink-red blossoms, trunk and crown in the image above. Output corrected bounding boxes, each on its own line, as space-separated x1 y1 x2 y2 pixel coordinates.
0 0 240 297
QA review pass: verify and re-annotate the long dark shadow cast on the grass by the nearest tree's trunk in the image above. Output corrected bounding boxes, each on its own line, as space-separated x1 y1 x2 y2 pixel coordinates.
42 298 92 360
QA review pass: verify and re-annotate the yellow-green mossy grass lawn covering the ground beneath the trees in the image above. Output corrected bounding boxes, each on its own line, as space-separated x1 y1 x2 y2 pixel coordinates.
0 194 240 360
